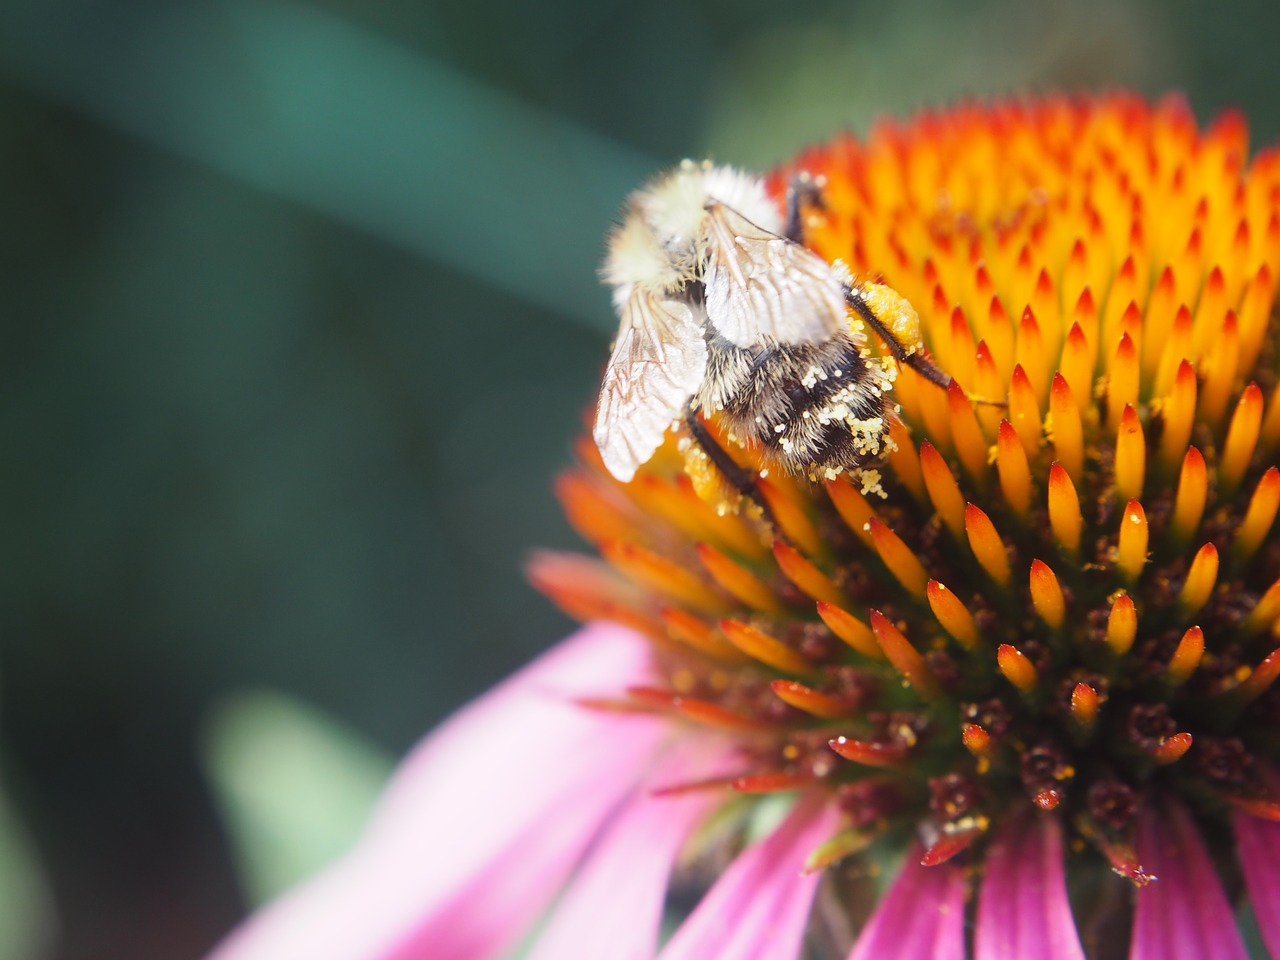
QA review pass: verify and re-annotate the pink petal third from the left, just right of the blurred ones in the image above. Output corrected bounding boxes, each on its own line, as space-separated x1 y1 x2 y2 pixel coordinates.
659 801 838 960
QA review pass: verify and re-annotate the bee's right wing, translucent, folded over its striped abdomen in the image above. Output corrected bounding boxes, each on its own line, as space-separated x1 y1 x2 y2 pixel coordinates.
704 202 847 347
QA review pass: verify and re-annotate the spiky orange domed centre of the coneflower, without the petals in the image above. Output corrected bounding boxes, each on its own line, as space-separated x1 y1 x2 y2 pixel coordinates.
535 95 1280 882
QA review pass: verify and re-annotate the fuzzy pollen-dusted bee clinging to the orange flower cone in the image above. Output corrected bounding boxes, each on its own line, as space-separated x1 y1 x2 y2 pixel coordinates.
593 160 950 493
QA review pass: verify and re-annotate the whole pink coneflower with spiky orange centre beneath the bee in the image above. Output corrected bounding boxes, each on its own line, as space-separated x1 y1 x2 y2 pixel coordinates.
207 95 1280 960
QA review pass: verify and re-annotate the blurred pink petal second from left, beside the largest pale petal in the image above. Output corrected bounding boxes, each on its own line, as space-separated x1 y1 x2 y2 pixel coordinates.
526 739 740 960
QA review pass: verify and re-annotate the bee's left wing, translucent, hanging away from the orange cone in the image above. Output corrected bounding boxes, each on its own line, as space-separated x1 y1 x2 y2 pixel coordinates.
593 288 707 483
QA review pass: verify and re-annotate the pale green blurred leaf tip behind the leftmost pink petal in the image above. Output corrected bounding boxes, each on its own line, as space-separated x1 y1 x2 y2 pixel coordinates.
204 691 393 904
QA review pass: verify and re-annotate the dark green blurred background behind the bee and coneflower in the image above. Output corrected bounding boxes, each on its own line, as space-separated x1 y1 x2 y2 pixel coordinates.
0 0 1280 960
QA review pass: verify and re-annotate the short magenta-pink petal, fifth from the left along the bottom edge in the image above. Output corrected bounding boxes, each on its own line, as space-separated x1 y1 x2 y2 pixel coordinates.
974 815 1084 960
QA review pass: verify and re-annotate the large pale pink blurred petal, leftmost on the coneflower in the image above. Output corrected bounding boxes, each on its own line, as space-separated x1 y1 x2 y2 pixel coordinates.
212 625 669 960
